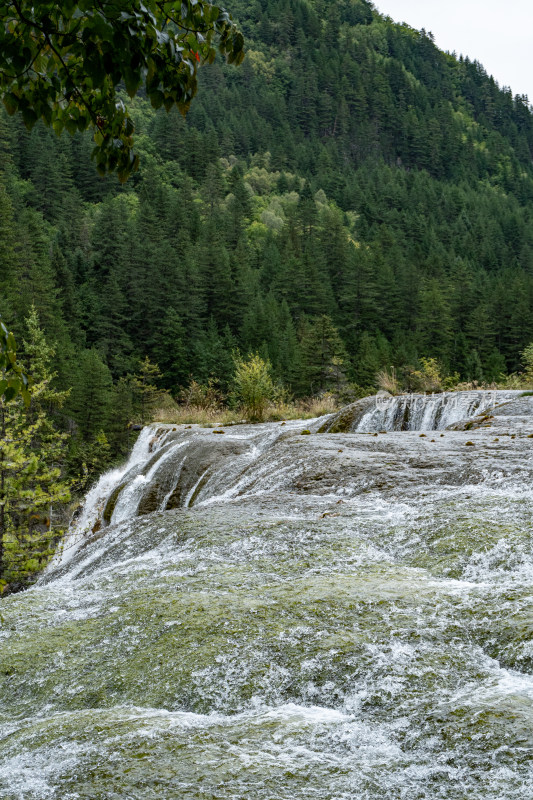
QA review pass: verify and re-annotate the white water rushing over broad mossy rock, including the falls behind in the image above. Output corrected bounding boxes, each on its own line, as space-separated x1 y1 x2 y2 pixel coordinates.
0 392 533 800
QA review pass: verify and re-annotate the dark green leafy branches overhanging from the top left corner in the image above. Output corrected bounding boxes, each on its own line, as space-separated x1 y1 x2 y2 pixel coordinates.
0 0 244 181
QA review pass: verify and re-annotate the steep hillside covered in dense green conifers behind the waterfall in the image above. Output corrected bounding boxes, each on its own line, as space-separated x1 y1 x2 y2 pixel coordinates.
0 0 533 466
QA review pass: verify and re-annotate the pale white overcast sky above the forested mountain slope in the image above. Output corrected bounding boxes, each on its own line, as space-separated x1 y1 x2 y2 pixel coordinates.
373 0 533 103
